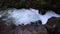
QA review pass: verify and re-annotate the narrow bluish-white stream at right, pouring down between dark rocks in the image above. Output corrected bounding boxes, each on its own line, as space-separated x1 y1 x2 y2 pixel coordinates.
40 11 60 24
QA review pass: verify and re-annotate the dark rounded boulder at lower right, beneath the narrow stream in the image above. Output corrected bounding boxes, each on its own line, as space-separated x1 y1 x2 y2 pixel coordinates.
45 17 60 34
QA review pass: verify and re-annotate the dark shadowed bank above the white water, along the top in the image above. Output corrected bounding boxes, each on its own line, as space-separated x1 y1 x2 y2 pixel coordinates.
0 0 60 14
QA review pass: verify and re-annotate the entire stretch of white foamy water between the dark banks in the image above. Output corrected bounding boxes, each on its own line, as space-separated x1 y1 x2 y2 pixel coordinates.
0 8 60 25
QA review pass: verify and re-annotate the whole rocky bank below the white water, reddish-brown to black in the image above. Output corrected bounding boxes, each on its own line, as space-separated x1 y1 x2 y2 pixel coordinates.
0 17 60 34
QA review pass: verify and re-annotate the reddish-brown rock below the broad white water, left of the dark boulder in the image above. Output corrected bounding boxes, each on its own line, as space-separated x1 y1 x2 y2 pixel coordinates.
0 20 48 34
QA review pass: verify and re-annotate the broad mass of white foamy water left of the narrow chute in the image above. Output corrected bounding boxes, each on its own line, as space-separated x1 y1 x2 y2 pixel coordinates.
9 9 40 25
